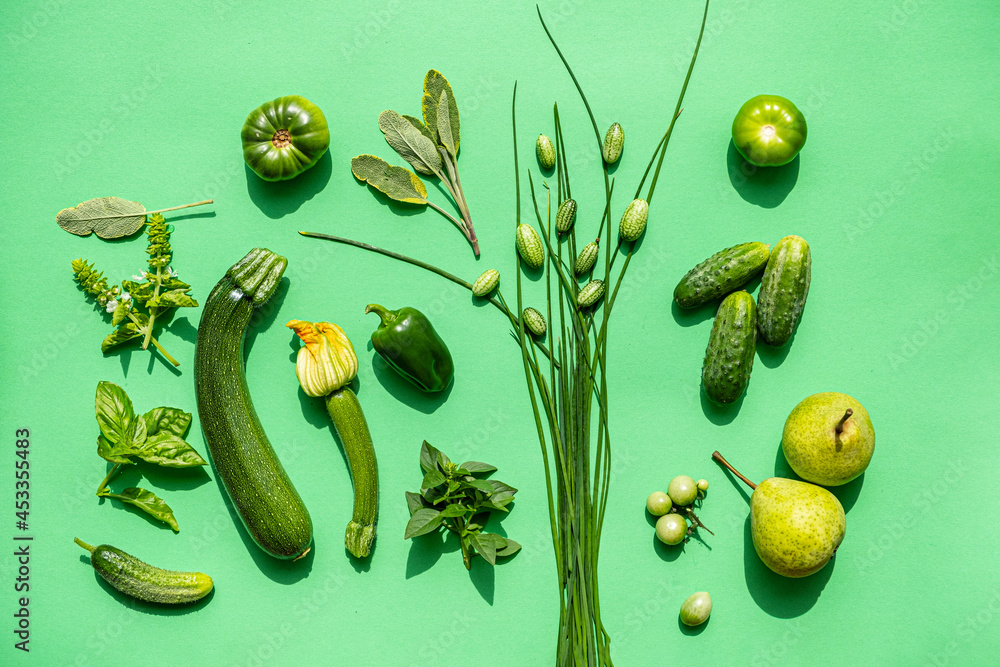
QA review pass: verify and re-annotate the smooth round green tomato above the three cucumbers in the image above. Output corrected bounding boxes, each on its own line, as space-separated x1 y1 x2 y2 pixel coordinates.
733 95 807 167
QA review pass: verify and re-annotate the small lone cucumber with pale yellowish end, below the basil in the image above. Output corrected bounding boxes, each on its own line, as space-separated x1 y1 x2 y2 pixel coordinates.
73 538 214 604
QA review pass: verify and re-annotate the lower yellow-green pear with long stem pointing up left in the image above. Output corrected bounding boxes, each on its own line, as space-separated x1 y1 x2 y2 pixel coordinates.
712 452 847 578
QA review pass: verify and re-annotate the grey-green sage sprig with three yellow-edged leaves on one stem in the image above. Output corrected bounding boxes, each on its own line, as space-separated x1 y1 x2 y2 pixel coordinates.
351 69 479 257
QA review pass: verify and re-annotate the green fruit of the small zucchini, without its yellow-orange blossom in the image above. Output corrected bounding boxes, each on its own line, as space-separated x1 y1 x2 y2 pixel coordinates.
326 386 378 558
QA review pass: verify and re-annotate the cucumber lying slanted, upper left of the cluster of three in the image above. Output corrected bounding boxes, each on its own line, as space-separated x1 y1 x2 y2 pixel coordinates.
674 241 770 308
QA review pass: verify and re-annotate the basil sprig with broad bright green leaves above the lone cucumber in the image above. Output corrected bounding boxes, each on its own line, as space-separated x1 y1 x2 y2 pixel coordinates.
94 382 207 532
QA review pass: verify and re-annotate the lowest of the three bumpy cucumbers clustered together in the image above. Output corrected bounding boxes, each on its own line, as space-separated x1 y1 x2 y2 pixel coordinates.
701 291 757 405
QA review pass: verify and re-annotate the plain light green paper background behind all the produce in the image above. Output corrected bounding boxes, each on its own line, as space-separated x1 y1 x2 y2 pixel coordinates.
0 0 1000 665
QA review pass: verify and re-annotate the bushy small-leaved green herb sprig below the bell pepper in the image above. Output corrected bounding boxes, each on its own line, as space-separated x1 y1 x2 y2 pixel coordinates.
403 440 521 570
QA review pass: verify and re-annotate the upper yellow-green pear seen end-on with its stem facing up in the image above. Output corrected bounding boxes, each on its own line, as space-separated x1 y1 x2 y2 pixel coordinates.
781 391 875 486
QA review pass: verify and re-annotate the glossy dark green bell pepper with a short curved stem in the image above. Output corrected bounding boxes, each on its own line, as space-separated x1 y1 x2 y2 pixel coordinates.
365 303 455 392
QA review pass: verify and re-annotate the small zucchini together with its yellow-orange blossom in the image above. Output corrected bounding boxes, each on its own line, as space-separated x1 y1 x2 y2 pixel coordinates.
285 320 378 558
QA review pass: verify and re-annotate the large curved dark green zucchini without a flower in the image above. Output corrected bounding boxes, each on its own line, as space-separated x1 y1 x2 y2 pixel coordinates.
194 248 312 558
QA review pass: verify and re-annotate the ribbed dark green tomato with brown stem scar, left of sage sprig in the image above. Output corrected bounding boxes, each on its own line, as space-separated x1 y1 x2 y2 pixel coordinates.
241 95 330 181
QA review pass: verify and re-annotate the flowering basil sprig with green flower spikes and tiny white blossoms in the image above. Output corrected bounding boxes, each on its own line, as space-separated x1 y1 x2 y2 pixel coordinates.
72 213 198 366
